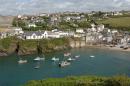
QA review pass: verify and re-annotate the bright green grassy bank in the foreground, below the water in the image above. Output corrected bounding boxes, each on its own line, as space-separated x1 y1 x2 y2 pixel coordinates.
25 76 130 86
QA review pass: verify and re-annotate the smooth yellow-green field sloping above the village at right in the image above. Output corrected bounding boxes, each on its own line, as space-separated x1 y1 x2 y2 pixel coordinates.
97 17 130 30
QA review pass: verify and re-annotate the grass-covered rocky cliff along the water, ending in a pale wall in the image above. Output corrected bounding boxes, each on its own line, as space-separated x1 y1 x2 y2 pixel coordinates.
0 38 86 56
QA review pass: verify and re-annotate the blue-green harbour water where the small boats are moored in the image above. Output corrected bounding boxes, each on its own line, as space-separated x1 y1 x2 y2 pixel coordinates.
0 48 130 86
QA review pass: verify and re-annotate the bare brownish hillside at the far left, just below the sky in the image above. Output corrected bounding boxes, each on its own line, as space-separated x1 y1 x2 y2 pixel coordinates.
0 16 14 27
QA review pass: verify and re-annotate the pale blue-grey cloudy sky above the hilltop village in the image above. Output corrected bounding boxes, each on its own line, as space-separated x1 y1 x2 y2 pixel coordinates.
0 0 130 15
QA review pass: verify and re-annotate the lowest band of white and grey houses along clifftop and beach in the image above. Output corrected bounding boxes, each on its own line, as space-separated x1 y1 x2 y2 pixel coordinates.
0 21 130 46
